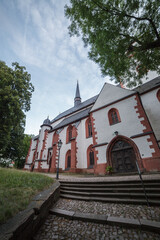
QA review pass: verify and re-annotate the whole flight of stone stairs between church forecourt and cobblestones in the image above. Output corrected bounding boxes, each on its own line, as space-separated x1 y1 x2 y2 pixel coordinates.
60 179 160 206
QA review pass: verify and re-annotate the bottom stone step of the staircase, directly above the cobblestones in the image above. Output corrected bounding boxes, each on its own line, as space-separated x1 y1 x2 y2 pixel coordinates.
60 194 160 206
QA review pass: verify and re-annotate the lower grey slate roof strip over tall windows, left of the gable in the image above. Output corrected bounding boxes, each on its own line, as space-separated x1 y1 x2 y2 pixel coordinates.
52 107 92 130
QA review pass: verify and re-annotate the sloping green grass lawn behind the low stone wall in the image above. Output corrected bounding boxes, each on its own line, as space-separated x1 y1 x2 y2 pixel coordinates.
0 168 54 224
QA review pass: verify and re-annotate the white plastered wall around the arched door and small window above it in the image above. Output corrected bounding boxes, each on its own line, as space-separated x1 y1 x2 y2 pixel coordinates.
93 96 154 164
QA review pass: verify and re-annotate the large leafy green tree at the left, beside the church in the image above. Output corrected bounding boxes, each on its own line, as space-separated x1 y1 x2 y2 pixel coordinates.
0 61 34 159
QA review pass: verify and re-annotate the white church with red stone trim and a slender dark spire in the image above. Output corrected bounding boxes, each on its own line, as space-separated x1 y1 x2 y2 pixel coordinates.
24 77 160 174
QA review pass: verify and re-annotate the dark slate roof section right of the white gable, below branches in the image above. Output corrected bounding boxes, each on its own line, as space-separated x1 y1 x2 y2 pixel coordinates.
134 76 160 94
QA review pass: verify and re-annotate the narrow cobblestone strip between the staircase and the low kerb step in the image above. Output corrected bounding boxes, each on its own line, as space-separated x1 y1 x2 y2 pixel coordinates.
54 198 160 222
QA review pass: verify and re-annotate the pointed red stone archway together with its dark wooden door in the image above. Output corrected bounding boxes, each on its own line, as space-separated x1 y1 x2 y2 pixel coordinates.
107 136 143 173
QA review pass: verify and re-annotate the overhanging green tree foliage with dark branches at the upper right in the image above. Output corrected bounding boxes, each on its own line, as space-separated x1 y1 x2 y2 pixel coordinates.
65 0 160 85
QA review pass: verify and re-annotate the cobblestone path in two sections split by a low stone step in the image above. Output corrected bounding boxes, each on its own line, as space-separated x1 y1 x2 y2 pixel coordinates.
34 199 160 240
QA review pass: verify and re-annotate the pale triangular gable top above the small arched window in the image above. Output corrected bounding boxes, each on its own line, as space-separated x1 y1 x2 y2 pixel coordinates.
91 83 136 112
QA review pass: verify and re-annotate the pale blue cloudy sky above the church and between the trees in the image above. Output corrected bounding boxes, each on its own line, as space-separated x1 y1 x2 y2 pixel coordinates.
0 0 112 135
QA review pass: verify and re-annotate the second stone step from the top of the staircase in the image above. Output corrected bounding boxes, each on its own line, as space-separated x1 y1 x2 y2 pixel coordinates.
61 185 160 193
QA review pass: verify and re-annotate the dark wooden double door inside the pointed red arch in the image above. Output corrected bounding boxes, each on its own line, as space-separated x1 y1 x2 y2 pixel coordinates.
111 140 137 173
